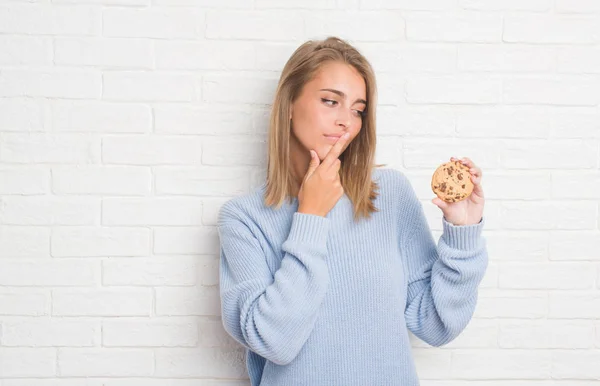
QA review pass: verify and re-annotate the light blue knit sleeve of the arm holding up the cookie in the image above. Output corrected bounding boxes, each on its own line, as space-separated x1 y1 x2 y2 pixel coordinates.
402 179 488 346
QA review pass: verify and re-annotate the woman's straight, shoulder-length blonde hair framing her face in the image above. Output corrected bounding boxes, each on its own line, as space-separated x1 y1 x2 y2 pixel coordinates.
265 37 381 221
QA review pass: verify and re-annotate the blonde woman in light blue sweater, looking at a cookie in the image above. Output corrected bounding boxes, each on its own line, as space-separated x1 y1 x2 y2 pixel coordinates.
218 38 487 386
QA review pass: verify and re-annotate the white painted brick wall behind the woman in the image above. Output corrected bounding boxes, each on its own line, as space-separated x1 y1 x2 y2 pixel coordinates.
0 0 600 386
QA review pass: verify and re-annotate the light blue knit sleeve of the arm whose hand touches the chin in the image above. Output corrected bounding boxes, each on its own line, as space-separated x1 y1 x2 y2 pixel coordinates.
219 208 330 365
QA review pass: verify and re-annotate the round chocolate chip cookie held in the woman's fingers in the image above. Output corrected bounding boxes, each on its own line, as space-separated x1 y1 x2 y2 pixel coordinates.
431 161 474 202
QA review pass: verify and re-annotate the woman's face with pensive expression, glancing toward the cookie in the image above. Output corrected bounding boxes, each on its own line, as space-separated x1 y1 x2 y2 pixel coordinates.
291 62 367 160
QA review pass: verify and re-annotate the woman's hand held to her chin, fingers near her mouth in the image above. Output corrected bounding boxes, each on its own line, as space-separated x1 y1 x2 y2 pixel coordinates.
298 133 350 217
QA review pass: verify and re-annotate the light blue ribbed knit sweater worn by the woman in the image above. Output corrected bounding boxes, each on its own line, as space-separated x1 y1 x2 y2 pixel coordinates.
218 169 488 386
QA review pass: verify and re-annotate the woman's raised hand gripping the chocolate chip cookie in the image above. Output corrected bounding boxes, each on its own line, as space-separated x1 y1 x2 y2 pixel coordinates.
431 157 485 226
